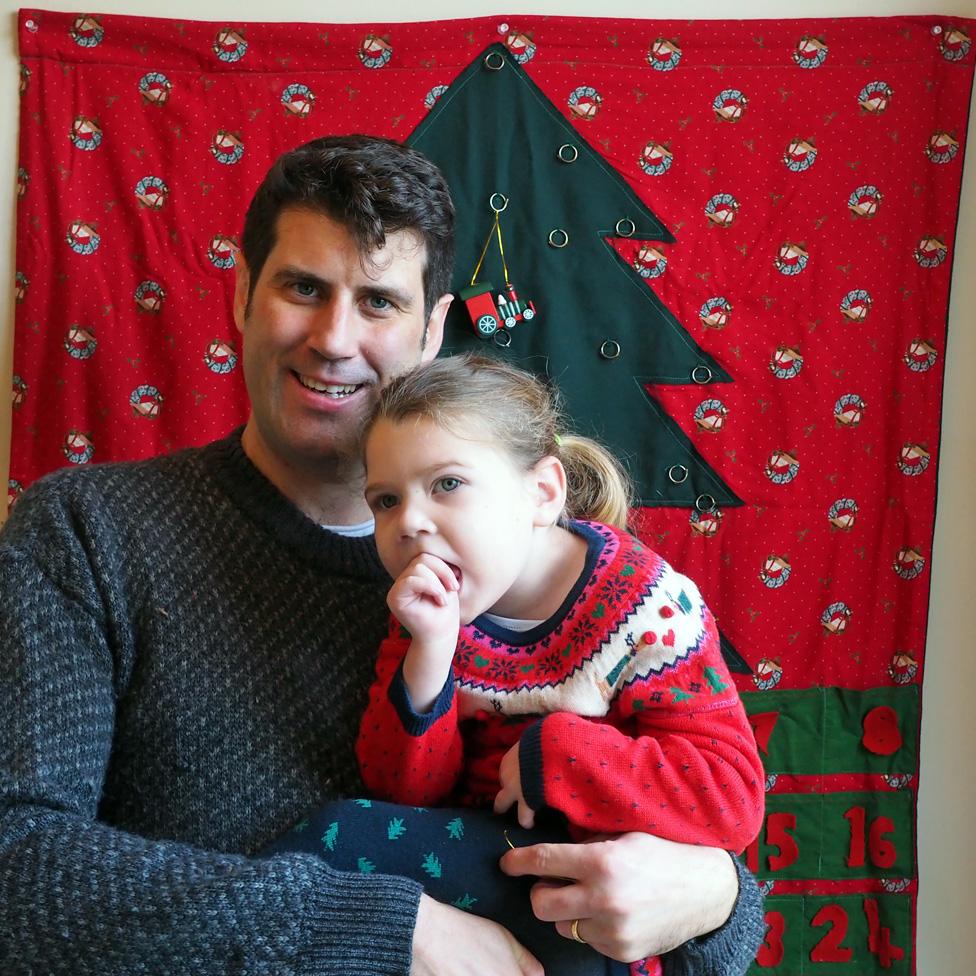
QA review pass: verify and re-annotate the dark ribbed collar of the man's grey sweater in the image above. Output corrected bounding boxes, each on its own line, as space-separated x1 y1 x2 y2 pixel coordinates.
200 427 389 580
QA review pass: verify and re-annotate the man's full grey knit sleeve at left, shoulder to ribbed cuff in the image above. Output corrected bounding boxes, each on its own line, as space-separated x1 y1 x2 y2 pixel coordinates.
0 493 420 976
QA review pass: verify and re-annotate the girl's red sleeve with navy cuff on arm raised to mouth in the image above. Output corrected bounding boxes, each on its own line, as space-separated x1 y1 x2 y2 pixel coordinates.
356 620 463 806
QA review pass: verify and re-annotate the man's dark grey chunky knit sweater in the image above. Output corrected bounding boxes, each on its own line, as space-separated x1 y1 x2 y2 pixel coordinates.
0 434 762 976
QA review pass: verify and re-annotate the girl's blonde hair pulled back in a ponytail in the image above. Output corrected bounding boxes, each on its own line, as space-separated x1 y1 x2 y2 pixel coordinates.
363 355 633 529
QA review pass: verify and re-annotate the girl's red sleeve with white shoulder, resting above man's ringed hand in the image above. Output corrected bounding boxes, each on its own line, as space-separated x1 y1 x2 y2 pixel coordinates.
519 574 764 852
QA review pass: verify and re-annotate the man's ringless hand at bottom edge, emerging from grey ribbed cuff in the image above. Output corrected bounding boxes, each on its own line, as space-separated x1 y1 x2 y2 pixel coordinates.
410 895 544 976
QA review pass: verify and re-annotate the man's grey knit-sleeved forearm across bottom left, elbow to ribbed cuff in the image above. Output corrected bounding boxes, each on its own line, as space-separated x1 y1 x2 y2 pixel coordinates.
0 807 420 976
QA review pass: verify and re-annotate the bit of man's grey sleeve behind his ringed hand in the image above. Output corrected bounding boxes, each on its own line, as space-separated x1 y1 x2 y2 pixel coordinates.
662 858 766 976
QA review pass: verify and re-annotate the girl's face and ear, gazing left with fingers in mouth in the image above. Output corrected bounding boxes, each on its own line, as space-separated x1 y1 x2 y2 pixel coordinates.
365 418 563 624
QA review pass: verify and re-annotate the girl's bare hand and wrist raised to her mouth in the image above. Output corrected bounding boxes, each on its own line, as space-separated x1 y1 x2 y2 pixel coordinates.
386 553 461 713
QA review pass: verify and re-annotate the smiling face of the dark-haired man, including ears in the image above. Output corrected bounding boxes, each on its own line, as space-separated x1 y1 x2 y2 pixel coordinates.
234 210 450 477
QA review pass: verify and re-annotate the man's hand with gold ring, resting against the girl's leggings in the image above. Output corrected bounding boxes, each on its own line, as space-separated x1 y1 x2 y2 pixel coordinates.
501 834 739 962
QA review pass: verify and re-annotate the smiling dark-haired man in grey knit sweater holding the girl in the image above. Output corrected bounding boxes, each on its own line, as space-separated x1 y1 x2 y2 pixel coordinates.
0 137 761 976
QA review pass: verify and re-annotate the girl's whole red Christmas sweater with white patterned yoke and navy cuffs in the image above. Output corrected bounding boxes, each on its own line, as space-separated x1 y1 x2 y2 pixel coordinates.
358 522 763 851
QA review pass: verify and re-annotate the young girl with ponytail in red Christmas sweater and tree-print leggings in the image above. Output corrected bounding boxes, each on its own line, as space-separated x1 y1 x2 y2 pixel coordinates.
266 357 763 974
